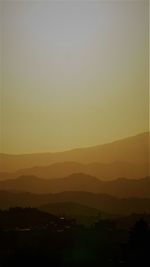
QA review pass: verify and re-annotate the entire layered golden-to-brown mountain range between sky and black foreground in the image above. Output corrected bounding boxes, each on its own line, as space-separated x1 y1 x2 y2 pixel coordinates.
0 133 150 218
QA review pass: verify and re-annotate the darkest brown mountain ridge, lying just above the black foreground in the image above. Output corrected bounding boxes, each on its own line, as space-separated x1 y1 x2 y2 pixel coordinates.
0 191 150 216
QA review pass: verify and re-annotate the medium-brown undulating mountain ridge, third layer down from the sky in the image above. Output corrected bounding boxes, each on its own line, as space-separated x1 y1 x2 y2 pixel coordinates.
0 173 150 198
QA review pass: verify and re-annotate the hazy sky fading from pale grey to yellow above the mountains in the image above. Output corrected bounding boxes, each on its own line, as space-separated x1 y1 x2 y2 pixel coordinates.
0 0 148 153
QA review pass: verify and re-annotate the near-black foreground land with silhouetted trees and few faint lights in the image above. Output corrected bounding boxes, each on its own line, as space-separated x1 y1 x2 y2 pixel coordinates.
0 208 150 267
